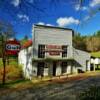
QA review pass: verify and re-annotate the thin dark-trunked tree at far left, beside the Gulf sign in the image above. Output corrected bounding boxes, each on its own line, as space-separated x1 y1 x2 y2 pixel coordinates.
0 21 14 85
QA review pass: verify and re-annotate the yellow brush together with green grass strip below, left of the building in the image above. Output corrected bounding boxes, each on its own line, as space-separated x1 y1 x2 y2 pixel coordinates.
0 58 32 89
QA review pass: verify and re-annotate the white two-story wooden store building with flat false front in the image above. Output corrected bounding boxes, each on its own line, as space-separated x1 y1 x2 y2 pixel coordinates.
19 25 90 78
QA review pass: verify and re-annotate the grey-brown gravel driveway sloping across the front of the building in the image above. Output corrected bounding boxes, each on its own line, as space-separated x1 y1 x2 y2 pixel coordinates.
0 74 100 100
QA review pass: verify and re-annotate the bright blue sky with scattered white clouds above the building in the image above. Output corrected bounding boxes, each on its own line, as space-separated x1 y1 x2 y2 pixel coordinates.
0 0 100 38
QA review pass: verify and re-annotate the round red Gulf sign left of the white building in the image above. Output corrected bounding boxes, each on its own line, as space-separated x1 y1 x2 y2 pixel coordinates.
6 39 21 55
